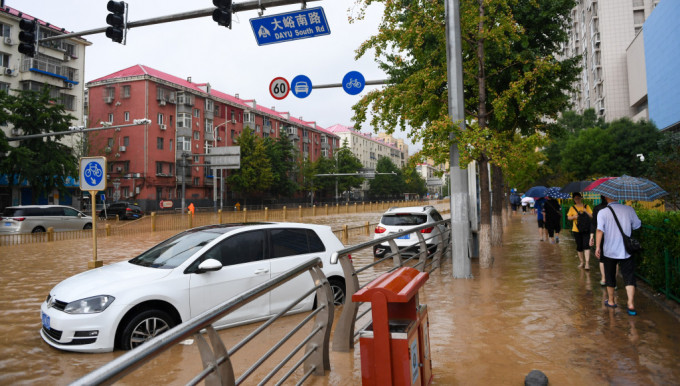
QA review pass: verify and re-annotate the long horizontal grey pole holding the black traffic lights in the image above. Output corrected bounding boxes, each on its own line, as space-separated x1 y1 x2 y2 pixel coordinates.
40 0 319 42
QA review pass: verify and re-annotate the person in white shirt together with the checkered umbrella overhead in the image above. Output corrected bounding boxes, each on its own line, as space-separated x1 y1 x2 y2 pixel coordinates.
592 175 668 316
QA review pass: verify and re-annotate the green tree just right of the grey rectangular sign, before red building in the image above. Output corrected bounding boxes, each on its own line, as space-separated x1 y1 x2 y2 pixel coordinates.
228 129 274 203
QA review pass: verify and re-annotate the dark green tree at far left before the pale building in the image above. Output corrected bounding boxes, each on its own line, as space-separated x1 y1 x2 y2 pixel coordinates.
0 87 78 203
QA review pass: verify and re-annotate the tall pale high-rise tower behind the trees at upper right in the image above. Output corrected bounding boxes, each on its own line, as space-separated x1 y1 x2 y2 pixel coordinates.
562 0 659 122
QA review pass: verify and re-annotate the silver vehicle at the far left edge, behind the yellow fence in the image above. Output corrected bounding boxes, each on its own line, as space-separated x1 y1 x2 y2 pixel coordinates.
0 205 92 234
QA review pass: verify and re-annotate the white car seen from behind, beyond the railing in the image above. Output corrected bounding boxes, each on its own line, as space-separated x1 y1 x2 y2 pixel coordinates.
373 205 446 258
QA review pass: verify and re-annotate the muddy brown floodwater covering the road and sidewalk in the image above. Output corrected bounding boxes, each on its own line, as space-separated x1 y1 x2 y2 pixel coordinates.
0 210 680 385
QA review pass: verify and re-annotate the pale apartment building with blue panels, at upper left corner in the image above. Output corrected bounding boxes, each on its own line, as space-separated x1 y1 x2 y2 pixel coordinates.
0 6 92 146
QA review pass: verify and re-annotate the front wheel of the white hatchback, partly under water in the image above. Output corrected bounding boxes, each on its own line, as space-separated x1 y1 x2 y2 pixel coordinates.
119 310 175 350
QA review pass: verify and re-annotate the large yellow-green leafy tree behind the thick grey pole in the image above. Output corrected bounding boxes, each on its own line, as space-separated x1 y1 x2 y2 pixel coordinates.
354 0 580 267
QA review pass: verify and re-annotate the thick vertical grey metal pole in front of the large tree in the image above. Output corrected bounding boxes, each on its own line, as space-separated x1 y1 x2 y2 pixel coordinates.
445 0 471 278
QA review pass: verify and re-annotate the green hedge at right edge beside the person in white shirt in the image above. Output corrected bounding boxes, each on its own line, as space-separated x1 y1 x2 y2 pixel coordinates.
633 208 680 302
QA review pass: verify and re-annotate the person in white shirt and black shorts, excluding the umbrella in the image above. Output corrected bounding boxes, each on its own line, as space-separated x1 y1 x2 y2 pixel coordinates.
595 197 642 316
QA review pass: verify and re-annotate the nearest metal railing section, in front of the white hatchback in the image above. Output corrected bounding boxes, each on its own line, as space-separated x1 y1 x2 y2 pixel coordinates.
72 257 334 385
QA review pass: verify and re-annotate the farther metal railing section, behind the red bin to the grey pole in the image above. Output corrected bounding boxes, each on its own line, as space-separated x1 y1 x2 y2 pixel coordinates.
331 220 451 352
